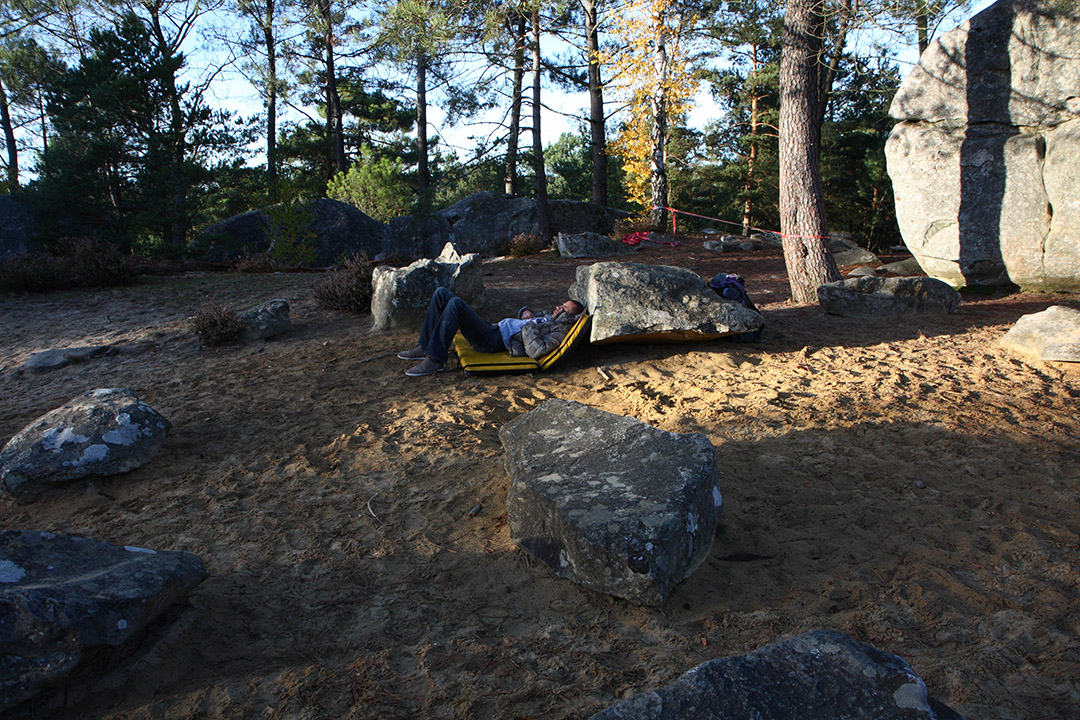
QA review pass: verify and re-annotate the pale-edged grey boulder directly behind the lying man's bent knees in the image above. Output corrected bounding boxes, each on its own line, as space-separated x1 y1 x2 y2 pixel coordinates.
372 243 486 330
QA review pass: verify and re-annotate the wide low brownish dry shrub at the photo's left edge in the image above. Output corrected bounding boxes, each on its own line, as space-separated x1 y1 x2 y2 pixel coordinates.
0 237 138 293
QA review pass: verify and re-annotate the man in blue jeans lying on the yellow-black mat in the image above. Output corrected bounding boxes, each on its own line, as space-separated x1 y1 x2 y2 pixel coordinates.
397 287 584 378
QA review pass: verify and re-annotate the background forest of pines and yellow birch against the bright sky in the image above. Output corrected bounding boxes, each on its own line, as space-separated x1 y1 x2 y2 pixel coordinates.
0 0 970 257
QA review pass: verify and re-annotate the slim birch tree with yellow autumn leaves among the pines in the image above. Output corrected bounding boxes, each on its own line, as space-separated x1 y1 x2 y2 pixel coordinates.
600 0 698 226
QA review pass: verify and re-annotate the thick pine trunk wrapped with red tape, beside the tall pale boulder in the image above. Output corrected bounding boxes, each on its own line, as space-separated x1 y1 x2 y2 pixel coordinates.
780 0 840 303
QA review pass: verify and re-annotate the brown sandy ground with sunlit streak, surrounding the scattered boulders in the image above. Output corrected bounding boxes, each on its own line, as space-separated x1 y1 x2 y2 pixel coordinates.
0 243 1080 719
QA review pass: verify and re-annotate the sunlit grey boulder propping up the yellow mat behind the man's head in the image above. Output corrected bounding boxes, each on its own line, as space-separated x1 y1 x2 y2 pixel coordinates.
570 262 765 342
